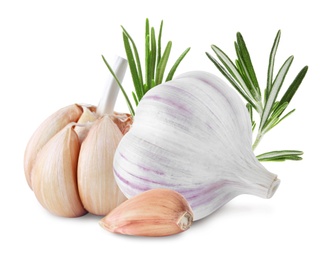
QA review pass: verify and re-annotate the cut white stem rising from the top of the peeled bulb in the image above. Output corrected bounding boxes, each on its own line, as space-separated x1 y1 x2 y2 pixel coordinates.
96 56 127 116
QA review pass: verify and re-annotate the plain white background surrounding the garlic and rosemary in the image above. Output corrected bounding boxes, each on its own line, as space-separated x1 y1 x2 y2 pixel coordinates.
0 0 325 260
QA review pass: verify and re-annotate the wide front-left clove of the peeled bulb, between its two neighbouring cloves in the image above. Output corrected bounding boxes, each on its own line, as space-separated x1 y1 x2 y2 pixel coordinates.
32 124 87 217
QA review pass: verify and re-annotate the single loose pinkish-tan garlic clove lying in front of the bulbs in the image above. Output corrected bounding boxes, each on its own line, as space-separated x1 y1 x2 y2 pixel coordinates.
99 189 193 236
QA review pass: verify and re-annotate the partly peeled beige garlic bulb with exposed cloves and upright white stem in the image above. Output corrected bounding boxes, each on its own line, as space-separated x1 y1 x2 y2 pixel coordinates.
24 58 133 217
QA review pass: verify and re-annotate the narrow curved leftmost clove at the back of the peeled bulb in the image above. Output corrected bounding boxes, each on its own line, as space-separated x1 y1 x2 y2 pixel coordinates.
24 104 82 189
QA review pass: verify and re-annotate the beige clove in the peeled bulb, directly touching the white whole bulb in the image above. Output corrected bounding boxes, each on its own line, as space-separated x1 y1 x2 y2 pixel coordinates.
78 115 126 215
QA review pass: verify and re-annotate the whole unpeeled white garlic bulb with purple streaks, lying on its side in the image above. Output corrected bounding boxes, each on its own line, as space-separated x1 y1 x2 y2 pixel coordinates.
114 71 280 220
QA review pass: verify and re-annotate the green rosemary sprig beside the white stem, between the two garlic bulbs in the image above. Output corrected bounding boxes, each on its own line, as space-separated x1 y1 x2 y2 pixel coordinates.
103 19 190 116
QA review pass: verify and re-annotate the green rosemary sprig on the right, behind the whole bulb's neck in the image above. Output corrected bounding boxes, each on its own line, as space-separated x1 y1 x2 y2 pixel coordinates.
206 30 308 161
